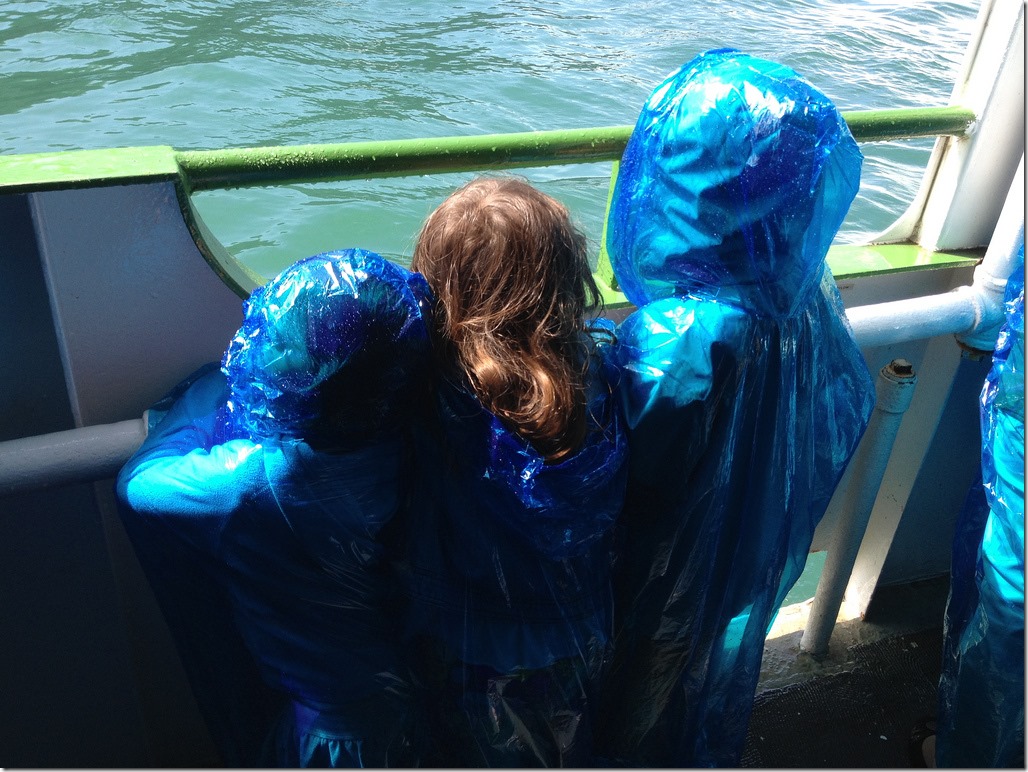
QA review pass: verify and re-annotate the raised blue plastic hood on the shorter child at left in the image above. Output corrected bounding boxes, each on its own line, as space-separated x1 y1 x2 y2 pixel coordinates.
222 249 431 441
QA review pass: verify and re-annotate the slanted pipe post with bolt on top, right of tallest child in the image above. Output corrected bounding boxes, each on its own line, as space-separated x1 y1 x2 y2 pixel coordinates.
800 359 917 656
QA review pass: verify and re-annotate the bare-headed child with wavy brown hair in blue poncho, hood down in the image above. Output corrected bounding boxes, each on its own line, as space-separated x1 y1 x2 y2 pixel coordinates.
398 178 626 767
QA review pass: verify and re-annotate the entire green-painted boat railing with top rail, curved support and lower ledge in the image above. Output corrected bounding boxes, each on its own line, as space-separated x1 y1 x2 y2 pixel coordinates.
0 106 976 308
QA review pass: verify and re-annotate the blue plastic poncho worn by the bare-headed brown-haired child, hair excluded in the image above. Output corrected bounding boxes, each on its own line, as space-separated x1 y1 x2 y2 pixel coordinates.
405 320 627 768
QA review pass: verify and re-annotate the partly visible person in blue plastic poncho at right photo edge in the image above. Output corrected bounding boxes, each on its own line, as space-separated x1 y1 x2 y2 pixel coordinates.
935 246 1025 768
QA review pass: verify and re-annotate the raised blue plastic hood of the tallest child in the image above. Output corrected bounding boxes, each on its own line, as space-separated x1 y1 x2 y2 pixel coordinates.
608 49 861 317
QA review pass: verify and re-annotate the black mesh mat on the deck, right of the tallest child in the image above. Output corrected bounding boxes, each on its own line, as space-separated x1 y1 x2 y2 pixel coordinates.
741 628 942 768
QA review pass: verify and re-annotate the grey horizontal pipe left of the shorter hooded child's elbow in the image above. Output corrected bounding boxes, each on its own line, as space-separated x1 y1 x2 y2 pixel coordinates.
0 418 146 495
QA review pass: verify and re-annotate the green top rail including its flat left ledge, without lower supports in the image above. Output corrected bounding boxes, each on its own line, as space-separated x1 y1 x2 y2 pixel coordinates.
0 107 975 193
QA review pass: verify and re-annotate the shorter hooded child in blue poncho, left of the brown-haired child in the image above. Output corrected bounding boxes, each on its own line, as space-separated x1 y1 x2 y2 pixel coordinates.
117 250 430 767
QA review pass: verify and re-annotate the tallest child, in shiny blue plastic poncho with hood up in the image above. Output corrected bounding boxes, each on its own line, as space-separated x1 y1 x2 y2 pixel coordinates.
598 49 874 767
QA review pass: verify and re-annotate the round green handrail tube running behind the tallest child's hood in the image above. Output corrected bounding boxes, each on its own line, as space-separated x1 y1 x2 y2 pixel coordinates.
176 107 975 191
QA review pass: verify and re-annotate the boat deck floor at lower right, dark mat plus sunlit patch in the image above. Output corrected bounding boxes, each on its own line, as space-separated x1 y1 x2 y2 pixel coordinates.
741 577 949 768
